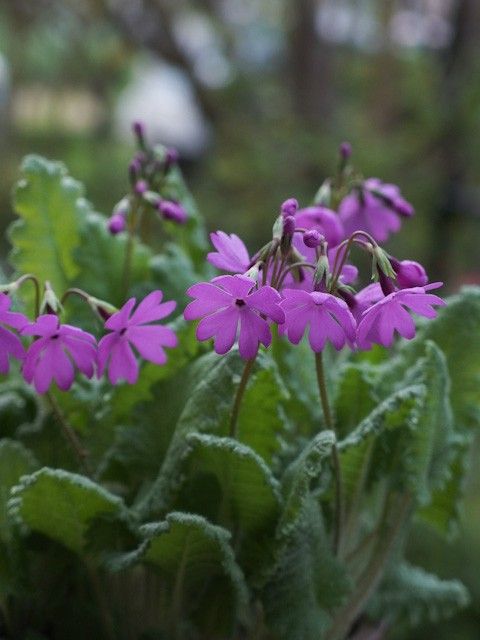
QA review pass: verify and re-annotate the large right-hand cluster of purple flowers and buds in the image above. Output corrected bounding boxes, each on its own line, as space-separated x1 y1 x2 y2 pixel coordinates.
184 146 445 359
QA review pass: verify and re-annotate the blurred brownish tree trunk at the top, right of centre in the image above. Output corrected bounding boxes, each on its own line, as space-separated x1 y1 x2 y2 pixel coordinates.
287 0 332 126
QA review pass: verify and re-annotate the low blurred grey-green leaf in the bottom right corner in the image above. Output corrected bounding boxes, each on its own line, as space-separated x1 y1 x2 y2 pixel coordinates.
369 563 470 628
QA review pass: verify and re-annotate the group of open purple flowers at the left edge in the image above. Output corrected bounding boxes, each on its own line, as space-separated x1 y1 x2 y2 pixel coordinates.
0 290 177 393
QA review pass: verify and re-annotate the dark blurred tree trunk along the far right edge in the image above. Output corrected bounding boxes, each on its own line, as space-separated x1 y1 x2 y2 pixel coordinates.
428 0 480 280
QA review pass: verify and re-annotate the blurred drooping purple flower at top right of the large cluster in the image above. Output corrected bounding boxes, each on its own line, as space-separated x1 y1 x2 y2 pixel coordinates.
338 178 413 242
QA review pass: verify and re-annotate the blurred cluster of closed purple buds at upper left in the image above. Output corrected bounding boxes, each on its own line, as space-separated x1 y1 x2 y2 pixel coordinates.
107 122 188 235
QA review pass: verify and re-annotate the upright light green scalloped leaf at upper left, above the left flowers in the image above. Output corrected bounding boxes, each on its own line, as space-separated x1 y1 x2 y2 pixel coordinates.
9 155 83 295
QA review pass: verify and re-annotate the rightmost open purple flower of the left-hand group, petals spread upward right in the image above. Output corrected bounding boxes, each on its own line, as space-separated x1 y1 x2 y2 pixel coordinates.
98 291 177 384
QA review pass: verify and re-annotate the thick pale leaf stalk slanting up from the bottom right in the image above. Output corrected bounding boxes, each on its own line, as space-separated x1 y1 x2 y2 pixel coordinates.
327 494 412 640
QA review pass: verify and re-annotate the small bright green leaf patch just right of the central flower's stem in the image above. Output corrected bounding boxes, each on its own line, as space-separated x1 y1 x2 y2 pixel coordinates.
334 363 378 438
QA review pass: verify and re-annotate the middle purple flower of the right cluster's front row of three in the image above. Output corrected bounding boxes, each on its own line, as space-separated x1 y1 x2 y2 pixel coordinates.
281 289 356 352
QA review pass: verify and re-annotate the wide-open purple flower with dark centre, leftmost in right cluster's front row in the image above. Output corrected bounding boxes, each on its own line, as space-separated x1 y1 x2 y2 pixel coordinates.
184 275 285 360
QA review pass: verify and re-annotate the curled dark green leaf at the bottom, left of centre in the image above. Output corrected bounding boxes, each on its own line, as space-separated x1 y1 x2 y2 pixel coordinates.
116 512 248 639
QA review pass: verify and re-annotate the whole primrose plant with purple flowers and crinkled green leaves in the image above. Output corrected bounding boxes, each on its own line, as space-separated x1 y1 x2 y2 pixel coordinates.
0 123 480 640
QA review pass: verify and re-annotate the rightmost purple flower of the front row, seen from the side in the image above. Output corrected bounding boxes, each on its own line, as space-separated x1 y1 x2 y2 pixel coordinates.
357 282 445 350
